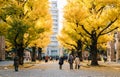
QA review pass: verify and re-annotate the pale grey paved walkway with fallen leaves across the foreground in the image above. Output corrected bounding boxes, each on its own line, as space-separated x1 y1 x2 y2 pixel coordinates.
0 61 120 77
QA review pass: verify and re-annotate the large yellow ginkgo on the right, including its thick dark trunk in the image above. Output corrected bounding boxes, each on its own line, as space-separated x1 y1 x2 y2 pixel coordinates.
64 0 120 65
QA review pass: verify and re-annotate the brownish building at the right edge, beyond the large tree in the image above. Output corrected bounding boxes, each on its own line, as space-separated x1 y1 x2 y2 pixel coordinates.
107 32 120 62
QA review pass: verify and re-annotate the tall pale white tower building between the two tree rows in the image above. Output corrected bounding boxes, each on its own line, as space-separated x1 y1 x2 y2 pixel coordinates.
46 0 60 56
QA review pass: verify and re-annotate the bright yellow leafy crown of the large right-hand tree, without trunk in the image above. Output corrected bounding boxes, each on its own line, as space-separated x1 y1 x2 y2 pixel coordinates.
61 0 120 50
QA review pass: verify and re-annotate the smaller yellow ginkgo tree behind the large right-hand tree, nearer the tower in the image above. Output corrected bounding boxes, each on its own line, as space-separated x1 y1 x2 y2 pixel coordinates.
58 23 82 58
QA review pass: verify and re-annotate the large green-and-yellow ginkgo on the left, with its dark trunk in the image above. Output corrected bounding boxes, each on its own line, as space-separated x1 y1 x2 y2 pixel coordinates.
0 0 52 65
